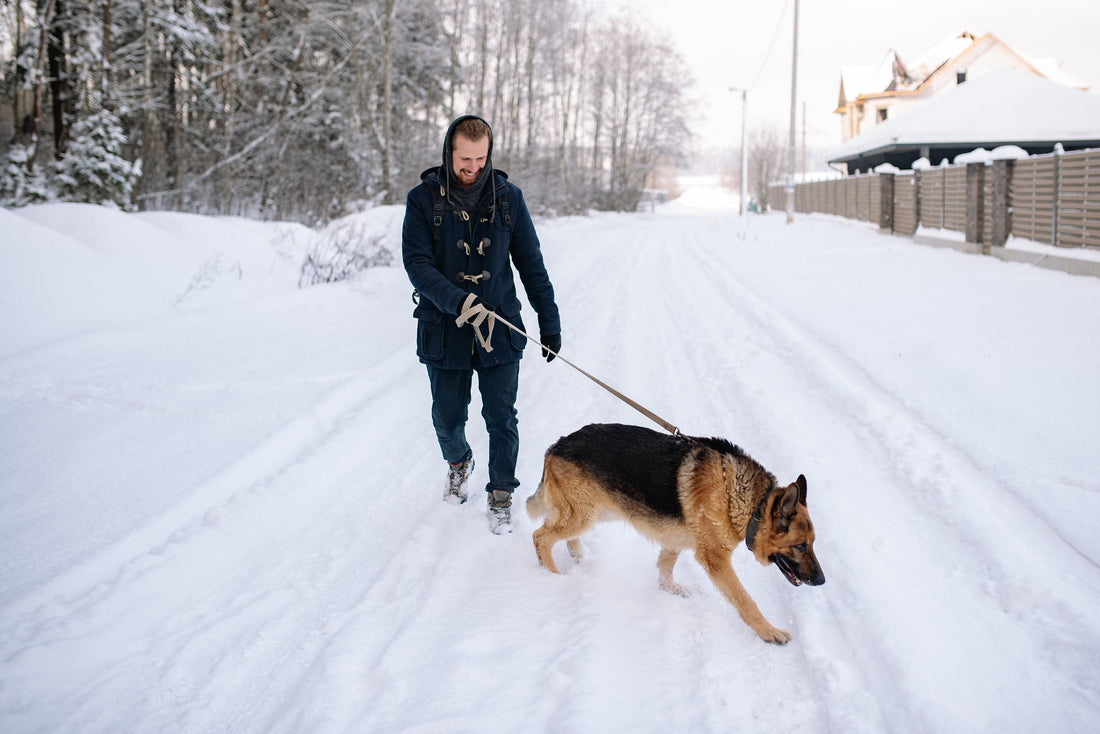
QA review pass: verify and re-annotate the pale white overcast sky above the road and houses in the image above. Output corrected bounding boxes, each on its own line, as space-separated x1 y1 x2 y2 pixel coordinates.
605 0 1100 158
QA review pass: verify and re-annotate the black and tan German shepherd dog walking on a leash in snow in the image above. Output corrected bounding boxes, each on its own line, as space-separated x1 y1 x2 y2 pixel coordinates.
527 424 825 645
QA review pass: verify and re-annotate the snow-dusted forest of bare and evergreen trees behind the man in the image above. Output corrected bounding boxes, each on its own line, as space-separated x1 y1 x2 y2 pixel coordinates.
0 0 692 226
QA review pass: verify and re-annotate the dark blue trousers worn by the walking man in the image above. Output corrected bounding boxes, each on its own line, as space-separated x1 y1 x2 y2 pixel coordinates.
427 361 519 492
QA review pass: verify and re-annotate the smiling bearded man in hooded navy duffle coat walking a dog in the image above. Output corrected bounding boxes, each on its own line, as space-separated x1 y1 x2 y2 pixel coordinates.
402 114 561 535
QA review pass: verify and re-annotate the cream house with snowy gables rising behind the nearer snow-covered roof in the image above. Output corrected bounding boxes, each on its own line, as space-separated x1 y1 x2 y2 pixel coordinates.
834 31 1088 141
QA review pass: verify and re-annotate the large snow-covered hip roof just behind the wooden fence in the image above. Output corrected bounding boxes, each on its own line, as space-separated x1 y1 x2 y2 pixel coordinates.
828 69 1100 163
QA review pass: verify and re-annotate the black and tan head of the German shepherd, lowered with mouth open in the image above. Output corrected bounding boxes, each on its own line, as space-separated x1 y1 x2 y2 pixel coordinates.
752 474 825 587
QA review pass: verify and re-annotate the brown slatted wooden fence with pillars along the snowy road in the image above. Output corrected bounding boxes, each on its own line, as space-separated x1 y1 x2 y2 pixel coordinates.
768 149 1100 249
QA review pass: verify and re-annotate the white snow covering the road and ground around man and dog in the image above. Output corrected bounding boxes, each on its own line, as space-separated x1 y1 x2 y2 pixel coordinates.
0 180 1100 733
